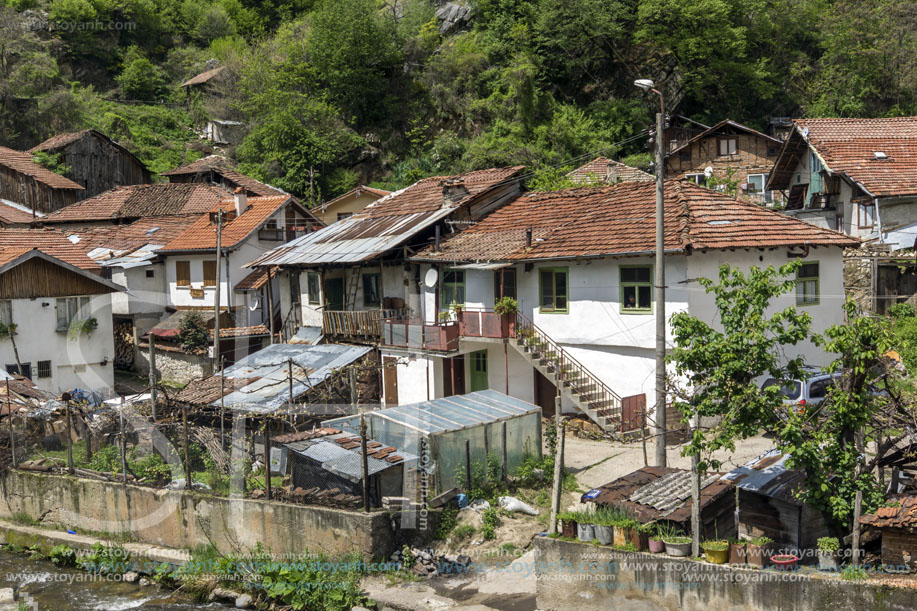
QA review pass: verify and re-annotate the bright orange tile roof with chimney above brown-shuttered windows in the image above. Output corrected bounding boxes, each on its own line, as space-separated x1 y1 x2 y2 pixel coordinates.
161 195 292 252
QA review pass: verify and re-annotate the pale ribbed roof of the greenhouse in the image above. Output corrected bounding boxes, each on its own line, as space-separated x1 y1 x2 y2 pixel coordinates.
325 390 541 435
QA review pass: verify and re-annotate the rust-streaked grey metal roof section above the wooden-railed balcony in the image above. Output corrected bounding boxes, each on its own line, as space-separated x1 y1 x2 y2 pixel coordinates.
249 208 454 266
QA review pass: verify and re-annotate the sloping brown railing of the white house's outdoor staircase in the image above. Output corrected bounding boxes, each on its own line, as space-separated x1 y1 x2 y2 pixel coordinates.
516 312 623 420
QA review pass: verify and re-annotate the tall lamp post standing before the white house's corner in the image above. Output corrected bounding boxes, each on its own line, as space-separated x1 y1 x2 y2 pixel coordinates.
634 79 666 467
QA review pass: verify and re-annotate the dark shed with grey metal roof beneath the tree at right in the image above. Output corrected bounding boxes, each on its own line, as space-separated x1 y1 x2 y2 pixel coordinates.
723 448 829 549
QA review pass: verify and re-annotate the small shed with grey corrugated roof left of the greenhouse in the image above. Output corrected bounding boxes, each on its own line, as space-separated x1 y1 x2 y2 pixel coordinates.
274 427 417 507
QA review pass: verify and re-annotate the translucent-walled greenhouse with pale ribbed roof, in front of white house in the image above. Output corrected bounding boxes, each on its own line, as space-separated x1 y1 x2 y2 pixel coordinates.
324 390 541 496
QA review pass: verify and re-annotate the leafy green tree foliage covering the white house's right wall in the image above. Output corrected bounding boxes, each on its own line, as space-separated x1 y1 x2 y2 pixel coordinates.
669 261 811 472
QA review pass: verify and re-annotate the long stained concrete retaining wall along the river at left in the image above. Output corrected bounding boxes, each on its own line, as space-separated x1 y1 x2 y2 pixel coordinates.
0 470 398 560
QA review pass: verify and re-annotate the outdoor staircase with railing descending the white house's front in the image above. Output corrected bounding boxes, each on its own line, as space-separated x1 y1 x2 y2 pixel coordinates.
510 312 623 433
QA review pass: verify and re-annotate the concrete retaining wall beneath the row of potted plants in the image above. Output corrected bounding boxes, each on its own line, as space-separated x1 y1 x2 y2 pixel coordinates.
534 538 917 611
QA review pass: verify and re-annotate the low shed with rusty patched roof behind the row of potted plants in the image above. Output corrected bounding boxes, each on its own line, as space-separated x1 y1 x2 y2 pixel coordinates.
583 467 736 539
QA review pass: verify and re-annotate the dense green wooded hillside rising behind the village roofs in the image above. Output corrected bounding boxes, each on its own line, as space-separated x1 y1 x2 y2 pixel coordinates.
0 0 917 200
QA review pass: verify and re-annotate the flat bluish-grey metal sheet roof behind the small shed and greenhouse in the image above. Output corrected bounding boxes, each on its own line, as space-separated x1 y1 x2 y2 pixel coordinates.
211 344 371 413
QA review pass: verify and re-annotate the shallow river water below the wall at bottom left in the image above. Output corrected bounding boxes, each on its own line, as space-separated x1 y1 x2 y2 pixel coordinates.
0 550 232 611
